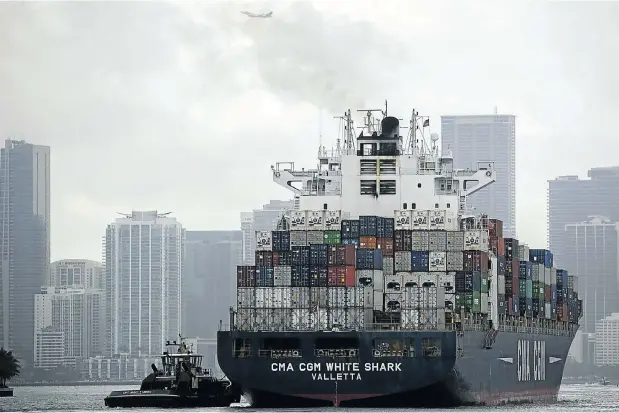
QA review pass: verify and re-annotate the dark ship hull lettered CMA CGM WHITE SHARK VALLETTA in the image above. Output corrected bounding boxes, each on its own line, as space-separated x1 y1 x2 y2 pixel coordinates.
217 327 573 408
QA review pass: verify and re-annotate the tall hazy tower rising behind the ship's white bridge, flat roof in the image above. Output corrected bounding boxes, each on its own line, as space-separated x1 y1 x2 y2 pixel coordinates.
441 115 516 237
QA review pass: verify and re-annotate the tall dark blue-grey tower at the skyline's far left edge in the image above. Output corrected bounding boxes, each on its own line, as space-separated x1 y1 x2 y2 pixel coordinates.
0 139 50 367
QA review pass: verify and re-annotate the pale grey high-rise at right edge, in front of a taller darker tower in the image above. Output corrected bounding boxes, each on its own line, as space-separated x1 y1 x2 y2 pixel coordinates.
562 216 619 333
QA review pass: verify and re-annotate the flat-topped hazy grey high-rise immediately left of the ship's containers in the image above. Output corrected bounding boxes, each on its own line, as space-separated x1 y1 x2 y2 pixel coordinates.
183 231 243 338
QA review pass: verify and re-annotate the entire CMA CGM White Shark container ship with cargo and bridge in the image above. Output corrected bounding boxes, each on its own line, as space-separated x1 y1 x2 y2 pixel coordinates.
217 103 582 408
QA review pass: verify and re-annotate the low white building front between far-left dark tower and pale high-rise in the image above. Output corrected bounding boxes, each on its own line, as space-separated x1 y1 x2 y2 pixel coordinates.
34 287 105 368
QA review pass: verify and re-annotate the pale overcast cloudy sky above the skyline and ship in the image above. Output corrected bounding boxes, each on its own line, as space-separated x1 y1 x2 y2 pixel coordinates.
0 0 619 260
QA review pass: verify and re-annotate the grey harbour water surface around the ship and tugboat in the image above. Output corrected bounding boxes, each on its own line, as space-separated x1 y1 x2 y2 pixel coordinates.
0 385 619 413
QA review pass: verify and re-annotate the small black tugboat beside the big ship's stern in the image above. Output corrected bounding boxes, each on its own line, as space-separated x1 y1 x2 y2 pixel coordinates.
105 335 241 408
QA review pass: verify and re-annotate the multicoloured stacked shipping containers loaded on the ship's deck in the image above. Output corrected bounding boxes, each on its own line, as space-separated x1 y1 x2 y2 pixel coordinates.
237 210 581 330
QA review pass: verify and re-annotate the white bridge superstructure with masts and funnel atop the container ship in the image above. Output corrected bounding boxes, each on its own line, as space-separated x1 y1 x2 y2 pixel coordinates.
272 104 496 219
